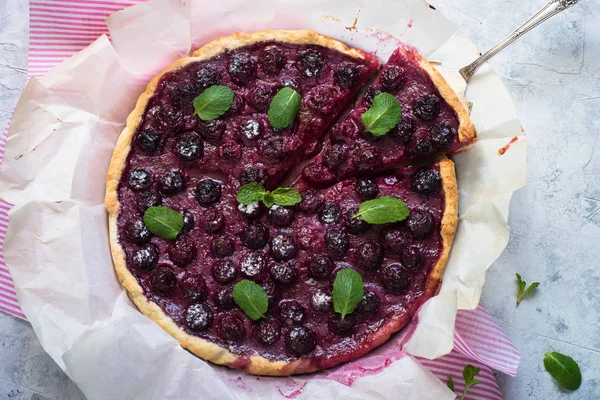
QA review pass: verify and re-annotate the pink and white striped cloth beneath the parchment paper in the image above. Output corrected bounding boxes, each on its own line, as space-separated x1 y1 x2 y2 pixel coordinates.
0 0 520 400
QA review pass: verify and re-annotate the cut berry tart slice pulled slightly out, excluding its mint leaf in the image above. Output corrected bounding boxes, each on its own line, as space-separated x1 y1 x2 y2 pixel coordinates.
298 47 477 187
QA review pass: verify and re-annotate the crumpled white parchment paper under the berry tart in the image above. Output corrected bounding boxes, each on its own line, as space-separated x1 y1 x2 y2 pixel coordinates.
0 0 525 400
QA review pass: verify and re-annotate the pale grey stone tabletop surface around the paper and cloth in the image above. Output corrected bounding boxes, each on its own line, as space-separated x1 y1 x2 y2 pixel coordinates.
0 0 600 400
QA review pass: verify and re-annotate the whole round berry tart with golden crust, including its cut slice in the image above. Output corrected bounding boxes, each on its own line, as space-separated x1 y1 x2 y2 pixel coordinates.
106 31 476 375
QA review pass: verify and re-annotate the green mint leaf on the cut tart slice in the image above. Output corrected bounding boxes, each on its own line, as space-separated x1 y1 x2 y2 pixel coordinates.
361 93 402 136
